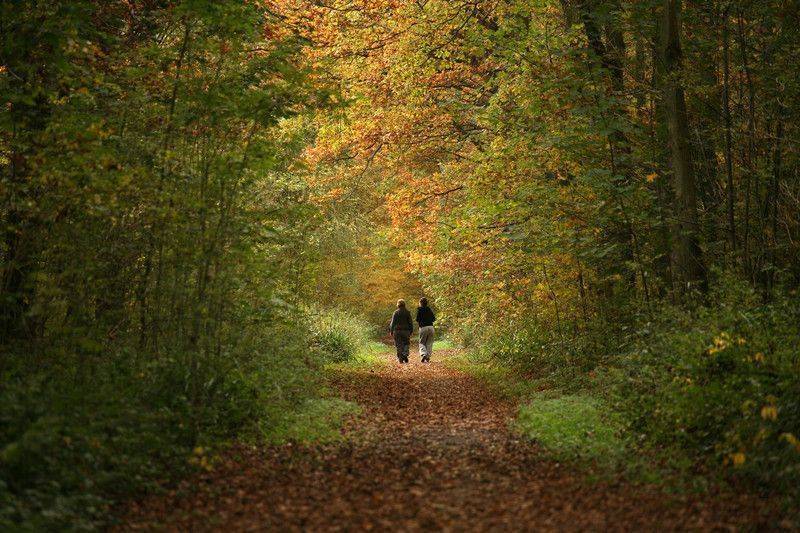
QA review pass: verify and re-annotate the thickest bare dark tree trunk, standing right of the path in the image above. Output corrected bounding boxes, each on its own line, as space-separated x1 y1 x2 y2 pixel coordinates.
661 0 708 294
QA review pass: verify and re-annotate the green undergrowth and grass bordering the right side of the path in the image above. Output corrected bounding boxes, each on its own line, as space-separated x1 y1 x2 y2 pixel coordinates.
466 279 800 501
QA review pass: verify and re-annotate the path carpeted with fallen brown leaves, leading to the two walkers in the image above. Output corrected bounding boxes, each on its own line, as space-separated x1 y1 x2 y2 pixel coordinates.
119 348 774 532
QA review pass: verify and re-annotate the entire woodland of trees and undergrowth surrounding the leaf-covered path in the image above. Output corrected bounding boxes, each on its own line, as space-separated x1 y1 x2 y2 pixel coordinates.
0 0 800 530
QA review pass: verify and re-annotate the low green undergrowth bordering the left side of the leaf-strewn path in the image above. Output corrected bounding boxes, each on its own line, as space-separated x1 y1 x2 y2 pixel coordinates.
0 306 368 531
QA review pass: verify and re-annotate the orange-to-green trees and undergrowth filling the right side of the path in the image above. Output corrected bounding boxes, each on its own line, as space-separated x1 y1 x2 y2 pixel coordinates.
275 0 800 504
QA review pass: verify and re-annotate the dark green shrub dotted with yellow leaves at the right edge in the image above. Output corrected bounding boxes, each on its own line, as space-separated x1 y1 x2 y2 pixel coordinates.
620 279 800 492
